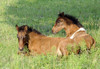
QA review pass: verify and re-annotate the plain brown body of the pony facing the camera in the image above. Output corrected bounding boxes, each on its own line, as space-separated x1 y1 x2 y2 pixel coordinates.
29 32 65 54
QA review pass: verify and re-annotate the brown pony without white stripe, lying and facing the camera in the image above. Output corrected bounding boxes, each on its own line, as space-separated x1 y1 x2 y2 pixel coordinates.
16 25 65 55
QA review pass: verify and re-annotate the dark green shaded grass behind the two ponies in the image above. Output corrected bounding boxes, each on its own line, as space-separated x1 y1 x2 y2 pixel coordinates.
5 0 99 35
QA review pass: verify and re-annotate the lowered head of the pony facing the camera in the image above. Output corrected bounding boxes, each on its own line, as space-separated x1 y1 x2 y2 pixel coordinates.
16 25 28 51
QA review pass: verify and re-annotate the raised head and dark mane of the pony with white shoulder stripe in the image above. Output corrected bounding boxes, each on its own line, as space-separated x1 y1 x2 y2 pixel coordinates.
52 12 82 34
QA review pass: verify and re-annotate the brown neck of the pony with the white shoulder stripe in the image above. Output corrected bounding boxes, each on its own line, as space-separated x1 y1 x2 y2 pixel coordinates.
64 21 79 37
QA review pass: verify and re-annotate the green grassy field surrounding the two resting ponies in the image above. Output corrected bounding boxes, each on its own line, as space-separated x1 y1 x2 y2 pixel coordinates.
0 0 100 69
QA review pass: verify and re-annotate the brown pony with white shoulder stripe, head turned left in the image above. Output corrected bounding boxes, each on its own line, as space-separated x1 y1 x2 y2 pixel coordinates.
52 12 95 55
